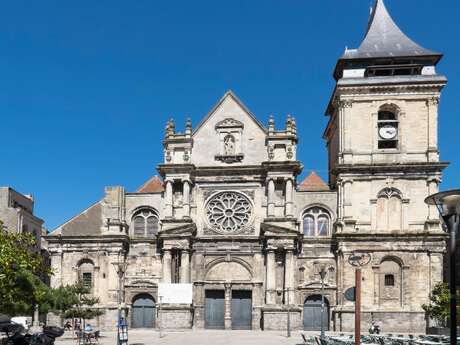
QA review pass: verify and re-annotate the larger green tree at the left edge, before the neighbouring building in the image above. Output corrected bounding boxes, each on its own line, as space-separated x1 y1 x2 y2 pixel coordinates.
0 221 53 315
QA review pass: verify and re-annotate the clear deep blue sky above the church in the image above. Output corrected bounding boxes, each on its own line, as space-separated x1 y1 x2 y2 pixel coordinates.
0 0 460 229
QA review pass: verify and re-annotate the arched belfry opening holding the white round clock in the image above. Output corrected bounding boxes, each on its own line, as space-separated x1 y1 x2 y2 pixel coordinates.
377 106 398 149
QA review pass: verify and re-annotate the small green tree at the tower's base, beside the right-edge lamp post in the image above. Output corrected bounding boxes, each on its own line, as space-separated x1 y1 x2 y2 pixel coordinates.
422 283 450 327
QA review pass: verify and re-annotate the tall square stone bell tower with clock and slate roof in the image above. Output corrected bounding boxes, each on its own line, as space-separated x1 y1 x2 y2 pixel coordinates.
324 0 447 331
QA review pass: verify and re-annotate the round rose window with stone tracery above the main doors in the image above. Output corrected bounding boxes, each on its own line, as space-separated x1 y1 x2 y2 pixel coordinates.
206 192 252 233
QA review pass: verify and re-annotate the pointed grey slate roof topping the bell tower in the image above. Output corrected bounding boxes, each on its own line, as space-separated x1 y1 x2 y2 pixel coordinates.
342 0 442 62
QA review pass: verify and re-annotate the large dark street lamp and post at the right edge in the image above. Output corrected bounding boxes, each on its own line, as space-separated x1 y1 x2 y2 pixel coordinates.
425 189 460 345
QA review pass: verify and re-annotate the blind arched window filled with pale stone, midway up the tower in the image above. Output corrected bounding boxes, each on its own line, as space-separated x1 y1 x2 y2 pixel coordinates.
376 188 402 231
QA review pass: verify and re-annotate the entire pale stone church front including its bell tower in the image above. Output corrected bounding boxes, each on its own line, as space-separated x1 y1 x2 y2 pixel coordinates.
47 0 447 332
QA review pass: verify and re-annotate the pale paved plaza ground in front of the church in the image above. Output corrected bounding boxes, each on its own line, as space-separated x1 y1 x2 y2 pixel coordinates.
56 330 312 345
